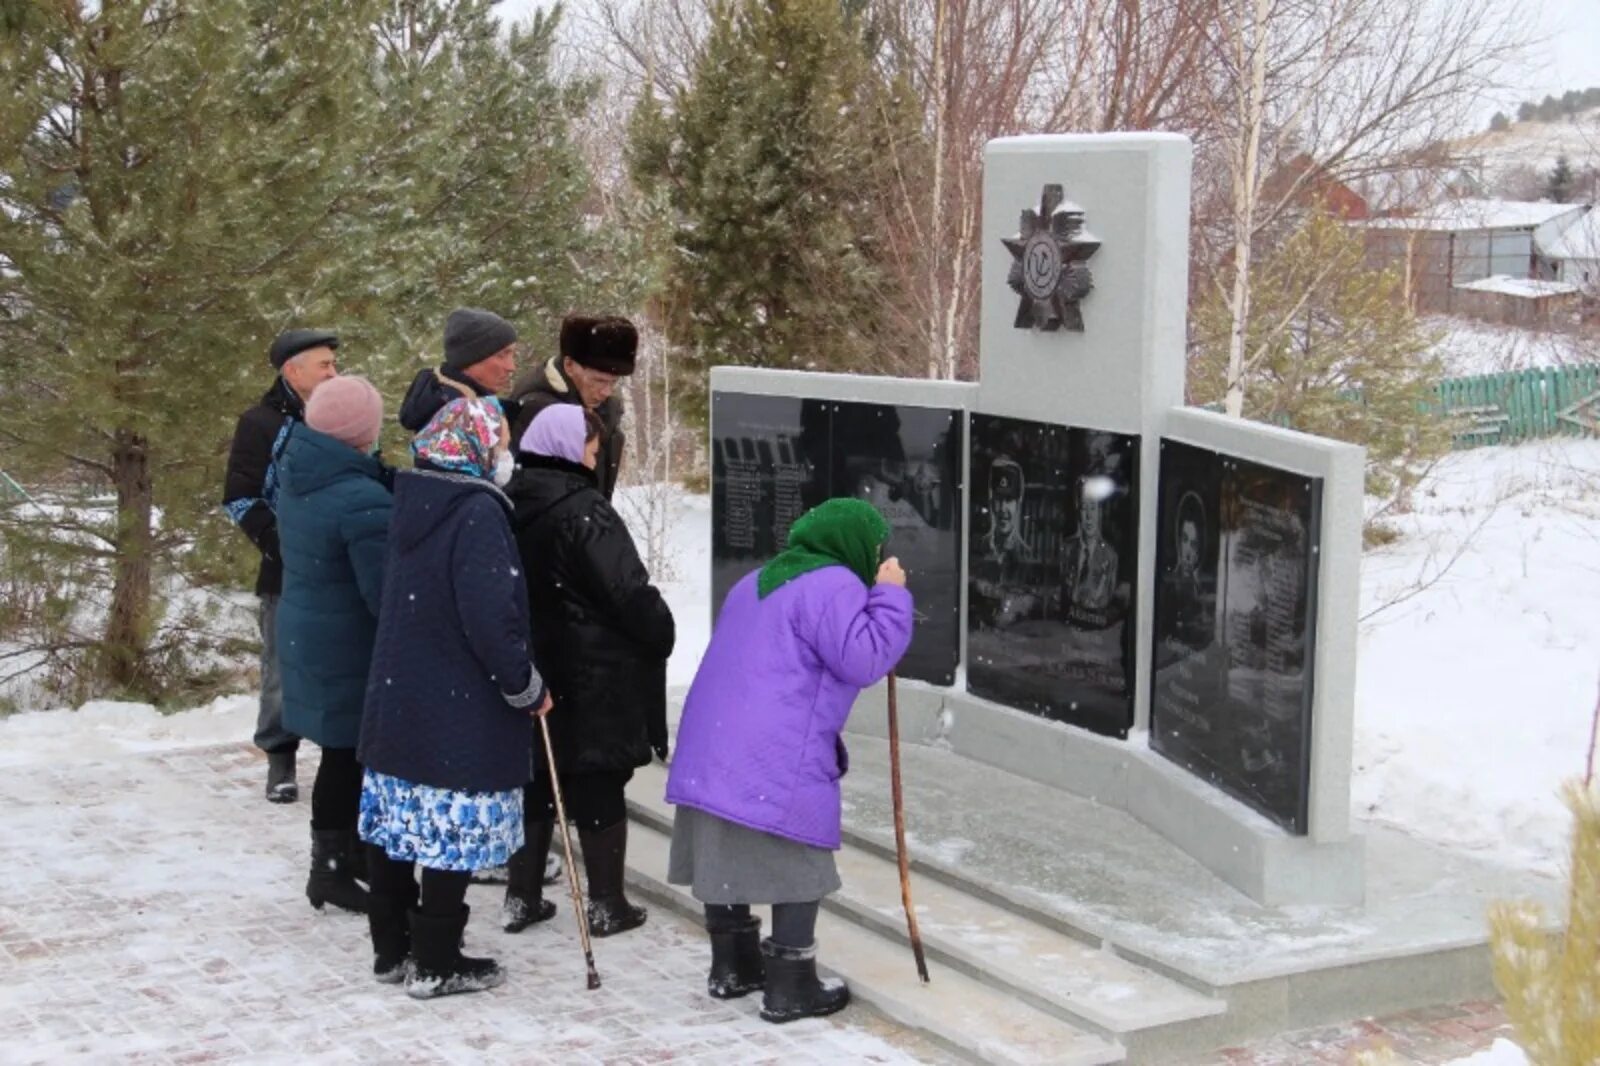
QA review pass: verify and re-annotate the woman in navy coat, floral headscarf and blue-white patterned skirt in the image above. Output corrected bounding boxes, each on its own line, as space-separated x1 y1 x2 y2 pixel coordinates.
360 399 550 999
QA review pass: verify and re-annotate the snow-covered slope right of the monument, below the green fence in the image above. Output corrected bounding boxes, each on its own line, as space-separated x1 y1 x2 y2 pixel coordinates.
1352 440 1600 872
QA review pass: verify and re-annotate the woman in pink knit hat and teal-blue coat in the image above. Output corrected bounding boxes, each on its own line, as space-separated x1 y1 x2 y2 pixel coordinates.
277 378 394 911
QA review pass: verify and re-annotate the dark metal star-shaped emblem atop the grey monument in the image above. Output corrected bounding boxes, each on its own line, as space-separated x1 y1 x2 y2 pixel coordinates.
1000 186 1099 333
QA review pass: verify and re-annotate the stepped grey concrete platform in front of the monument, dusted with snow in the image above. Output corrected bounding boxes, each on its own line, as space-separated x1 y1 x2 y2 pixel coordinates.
629 687 1562 1063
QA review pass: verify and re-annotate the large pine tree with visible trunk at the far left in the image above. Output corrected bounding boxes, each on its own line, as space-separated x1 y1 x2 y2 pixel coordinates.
0 0 380 693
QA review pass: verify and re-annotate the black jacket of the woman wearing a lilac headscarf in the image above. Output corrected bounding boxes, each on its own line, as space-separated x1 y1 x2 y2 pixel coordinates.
507 456 677 773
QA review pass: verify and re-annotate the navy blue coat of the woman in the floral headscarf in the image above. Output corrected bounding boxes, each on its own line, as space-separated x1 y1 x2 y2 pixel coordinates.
357 471 544 792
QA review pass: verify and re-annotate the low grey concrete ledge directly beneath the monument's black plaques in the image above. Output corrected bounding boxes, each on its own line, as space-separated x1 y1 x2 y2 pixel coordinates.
850 680 1365 906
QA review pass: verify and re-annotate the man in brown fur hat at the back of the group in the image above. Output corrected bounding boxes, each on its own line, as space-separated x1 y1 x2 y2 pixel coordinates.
512 314 638 499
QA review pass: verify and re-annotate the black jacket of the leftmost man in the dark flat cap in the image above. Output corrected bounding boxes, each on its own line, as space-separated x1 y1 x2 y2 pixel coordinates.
222 378 306 595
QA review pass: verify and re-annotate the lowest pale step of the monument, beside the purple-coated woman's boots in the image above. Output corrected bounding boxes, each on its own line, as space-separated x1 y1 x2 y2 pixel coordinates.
627 808 1126 1066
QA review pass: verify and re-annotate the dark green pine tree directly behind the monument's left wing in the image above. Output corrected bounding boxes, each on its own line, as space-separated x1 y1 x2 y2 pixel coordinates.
632 0 918 423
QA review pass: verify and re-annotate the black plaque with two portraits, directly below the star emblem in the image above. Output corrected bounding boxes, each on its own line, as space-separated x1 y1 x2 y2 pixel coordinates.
966 415 1139 736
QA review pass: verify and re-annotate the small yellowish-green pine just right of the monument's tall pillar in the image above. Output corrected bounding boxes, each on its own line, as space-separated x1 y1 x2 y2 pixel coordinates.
1189 214 1450 515
